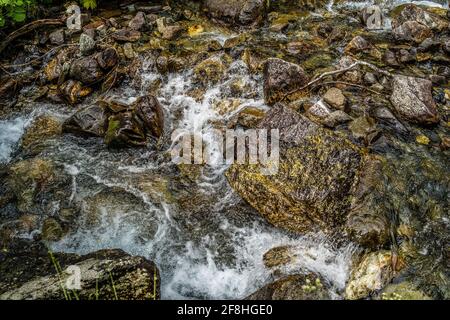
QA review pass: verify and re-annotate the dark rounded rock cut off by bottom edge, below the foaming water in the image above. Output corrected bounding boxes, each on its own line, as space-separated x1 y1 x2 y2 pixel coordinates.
246 274 331 300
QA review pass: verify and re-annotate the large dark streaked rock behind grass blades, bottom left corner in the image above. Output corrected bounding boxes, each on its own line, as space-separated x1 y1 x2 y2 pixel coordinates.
0 243 160 300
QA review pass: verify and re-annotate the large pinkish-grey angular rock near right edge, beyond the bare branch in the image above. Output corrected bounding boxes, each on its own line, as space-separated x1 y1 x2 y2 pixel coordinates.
390 75 439 124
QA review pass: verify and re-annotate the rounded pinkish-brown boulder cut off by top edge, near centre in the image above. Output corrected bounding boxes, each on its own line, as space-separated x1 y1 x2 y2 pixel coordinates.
204 0 266 25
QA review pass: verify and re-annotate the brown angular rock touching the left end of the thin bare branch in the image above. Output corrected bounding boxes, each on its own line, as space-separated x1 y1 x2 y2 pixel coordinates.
263 58 308 105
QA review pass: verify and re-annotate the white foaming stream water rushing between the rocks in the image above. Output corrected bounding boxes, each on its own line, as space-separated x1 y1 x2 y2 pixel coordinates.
8 0 448 299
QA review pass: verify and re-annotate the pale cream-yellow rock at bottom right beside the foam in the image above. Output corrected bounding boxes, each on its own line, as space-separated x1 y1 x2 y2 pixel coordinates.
345 250 395 300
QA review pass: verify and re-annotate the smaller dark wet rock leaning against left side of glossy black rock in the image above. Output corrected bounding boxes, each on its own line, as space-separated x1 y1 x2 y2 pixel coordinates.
63 105 107 137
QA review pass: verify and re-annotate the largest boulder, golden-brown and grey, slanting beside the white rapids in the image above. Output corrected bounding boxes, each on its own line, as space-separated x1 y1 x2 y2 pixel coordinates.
226 105 362 233
